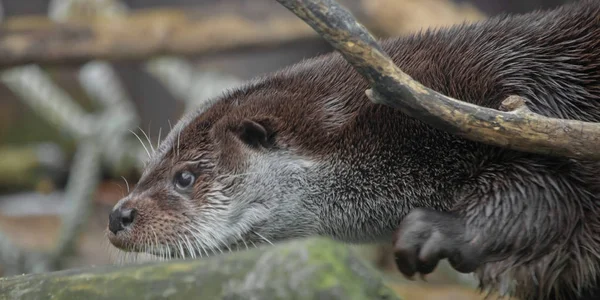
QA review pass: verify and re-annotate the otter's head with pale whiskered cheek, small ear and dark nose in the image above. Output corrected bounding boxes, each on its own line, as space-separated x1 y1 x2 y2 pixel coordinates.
107 84 328 257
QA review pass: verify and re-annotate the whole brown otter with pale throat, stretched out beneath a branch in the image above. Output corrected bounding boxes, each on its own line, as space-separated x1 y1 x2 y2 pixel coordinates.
108 0 600 299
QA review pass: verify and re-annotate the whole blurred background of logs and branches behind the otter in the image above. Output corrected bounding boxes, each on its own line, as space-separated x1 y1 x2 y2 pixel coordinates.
0 0 568 299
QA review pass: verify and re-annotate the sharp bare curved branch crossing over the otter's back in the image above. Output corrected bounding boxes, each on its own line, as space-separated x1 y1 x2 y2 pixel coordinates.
277 0 600 160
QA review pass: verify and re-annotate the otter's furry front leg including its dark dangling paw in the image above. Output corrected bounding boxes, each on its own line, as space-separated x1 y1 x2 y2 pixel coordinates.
394 161 600 299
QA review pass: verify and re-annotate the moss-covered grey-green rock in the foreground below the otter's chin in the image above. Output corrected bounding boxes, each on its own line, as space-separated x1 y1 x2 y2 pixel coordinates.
0 238 399 300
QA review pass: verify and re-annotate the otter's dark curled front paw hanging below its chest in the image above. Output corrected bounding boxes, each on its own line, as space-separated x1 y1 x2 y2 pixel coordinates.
393 208 481 278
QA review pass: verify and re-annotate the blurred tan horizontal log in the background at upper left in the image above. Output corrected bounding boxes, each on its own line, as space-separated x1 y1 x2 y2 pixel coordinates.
0 8 316 67
